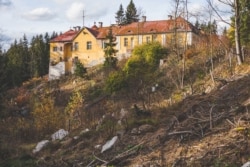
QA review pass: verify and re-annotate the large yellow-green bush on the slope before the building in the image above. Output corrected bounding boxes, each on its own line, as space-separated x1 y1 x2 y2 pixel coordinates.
105 43 167 95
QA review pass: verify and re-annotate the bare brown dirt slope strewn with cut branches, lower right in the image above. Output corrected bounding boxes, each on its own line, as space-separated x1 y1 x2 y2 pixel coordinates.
35 75 250 167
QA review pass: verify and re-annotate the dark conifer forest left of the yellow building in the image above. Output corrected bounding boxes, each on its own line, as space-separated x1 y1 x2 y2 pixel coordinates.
0 33 50 91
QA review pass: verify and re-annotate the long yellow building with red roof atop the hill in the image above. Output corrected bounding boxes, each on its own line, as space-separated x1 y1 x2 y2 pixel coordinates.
50 16 199 79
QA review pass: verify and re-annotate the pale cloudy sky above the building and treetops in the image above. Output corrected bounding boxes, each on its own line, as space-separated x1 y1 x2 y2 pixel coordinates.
0 0 231 48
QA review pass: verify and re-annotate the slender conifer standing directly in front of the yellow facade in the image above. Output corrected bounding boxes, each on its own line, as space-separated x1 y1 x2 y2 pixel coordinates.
104 26 118 68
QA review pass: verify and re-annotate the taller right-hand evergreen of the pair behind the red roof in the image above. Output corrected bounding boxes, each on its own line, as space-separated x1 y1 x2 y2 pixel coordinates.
126 0 139 24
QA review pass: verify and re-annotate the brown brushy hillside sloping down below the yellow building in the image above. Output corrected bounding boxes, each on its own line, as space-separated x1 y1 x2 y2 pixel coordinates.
0 51 250 167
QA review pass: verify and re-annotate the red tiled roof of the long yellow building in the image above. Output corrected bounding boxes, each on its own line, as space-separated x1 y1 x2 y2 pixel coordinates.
51 17 197 42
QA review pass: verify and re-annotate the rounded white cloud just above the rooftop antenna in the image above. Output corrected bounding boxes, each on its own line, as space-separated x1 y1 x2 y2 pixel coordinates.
66 2 84 21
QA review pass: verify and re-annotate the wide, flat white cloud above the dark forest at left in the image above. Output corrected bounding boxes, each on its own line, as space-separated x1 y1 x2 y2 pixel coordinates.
22 8 55 21
